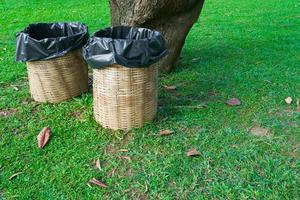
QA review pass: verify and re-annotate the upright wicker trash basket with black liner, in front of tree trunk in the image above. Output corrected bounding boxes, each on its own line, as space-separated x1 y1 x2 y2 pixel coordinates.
84 27 167 130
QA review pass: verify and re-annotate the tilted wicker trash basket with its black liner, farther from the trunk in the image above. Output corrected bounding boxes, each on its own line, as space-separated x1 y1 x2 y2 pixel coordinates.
17 23 88 103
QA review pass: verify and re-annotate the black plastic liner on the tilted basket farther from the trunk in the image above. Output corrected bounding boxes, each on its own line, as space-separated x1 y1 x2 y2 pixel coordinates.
16 22 89 62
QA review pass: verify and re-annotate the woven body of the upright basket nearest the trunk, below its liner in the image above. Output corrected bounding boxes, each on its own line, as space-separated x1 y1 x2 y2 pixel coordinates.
93 65 158 130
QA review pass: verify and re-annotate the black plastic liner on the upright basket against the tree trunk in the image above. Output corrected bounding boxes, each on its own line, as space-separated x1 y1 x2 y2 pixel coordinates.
84 26 168 68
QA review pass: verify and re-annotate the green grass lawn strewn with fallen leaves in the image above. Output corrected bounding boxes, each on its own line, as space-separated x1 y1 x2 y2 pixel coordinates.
0 0 300 199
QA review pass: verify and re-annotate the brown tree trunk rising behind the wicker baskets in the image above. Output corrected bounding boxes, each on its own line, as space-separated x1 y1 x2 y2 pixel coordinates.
110 0 204 72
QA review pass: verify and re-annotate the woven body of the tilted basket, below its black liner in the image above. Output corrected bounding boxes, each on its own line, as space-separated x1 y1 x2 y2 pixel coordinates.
26 50 88 103
